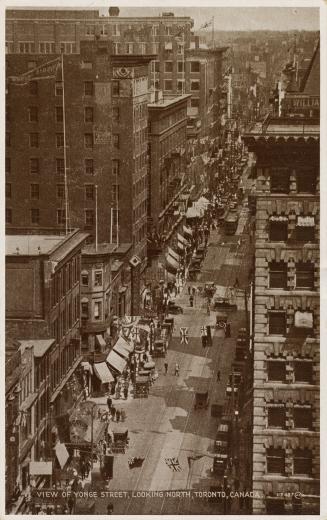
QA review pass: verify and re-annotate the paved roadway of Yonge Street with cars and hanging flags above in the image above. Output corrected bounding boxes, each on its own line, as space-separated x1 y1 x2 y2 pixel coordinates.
91 196 255 514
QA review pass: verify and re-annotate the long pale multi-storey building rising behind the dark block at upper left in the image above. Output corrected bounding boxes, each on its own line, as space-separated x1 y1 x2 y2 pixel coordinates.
6 8 226 137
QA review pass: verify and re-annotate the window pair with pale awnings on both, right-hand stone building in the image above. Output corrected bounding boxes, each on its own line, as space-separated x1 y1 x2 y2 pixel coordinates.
268 219 316 242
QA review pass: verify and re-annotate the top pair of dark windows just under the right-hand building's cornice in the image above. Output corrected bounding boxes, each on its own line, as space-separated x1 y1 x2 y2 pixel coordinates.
270 167 318 194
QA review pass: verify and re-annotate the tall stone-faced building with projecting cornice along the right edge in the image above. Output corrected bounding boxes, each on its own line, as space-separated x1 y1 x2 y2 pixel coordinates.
244 43 320 514
